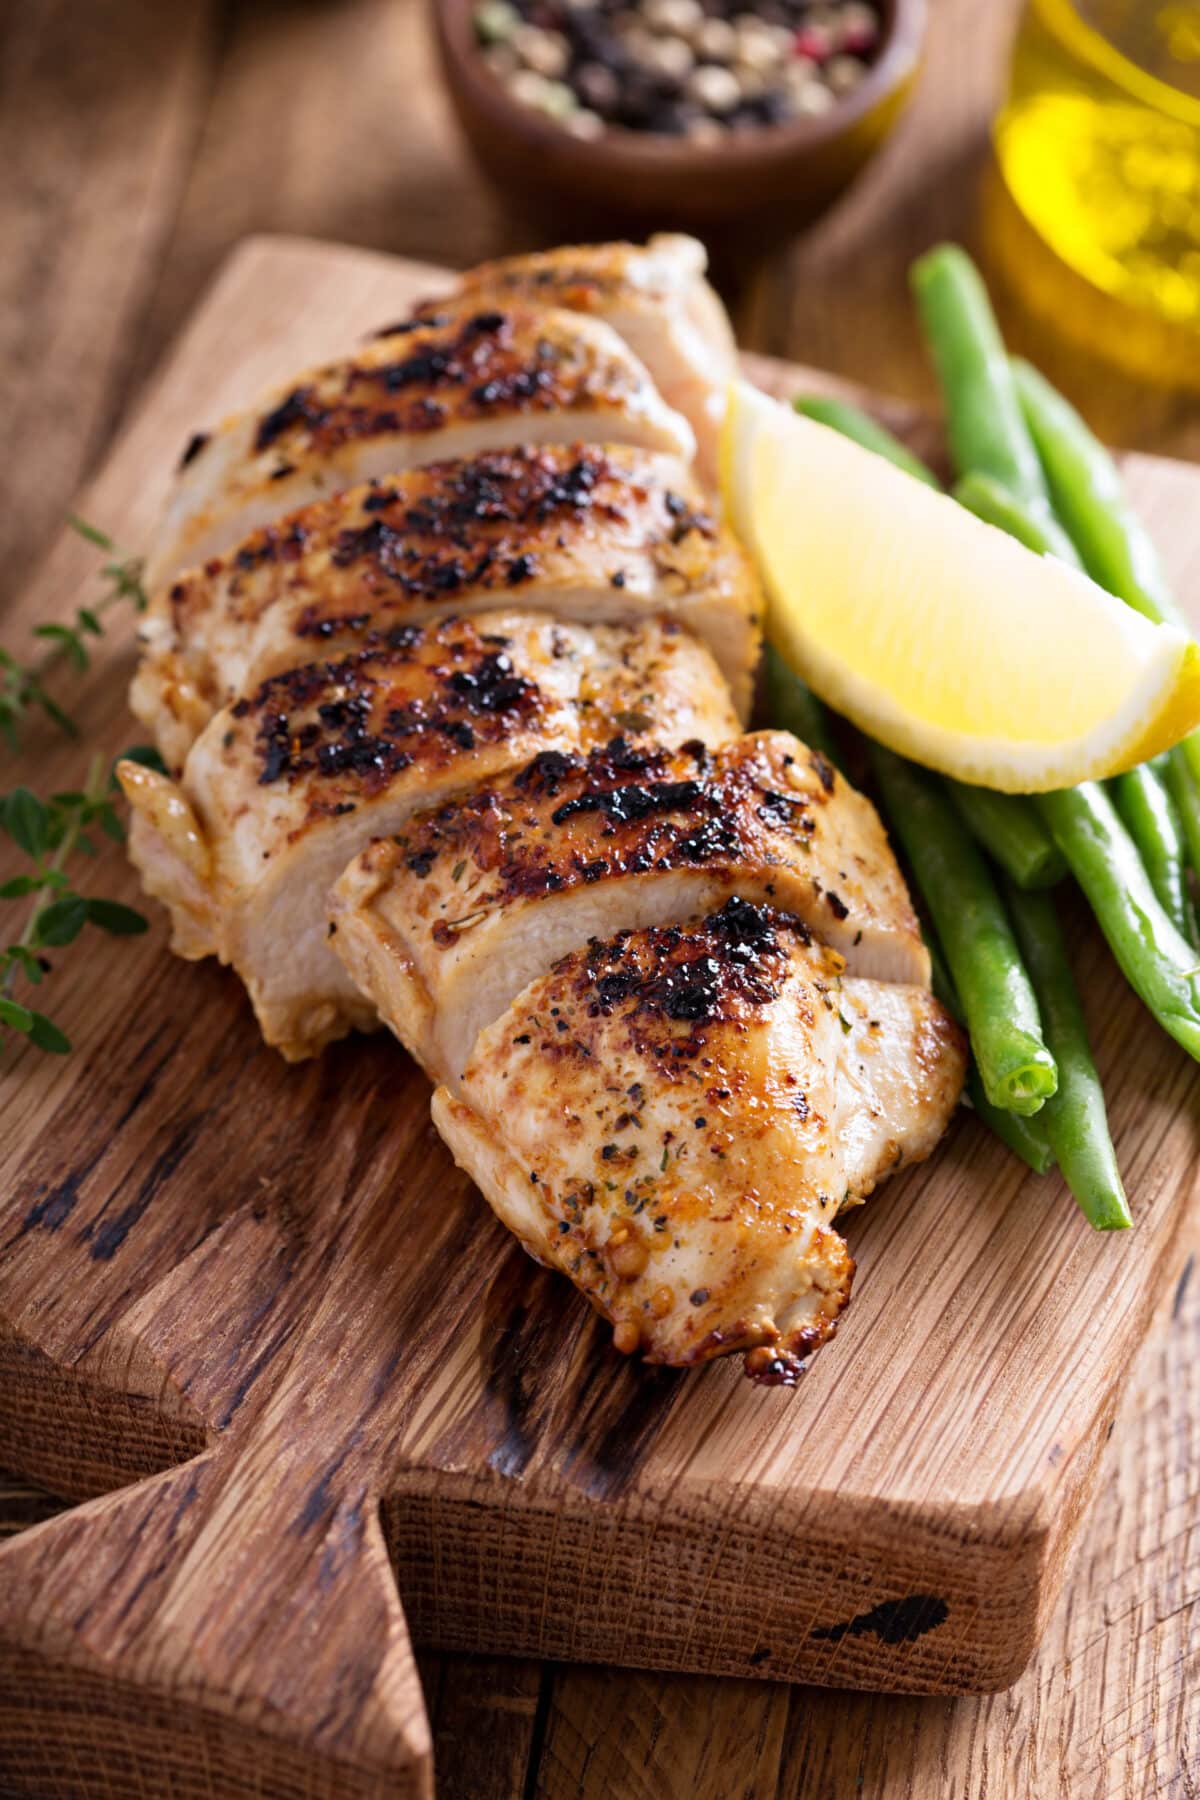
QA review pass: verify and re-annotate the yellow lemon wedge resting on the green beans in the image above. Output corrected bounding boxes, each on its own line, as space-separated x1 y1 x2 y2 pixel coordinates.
721 382 1200 794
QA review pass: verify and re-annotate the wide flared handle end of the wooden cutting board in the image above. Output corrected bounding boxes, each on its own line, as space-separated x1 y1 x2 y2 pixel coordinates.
0 1468 432 1800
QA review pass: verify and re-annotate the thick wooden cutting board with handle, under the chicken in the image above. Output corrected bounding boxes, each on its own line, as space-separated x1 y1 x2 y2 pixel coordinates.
0 239 1200 1796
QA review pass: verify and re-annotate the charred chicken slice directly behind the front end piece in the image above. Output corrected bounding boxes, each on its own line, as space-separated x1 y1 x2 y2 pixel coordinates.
331 731 928 1087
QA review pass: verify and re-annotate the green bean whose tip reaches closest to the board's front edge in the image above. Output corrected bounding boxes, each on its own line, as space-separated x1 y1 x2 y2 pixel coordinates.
1007 887 1133 1231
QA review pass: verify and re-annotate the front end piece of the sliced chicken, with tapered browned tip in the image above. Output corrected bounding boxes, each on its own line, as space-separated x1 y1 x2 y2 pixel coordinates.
434 900 964 1382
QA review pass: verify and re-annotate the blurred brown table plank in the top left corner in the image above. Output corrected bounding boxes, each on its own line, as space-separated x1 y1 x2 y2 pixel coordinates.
0 0 216 596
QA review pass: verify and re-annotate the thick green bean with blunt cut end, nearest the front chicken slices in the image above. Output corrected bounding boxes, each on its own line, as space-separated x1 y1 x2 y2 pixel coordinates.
871 743 1058 1116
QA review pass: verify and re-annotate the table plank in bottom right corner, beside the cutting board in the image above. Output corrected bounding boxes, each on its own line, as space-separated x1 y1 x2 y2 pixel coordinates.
779 1219 1200 1800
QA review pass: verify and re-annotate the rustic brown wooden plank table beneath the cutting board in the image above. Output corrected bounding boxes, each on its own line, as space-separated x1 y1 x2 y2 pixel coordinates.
0 0 1200 1800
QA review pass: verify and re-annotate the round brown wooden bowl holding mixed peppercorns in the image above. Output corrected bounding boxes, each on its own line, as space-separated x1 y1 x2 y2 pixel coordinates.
432 0 927 259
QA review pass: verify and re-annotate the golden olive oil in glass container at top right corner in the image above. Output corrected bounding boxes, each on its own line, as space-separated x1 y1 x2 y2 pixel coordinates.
995 0 1200 331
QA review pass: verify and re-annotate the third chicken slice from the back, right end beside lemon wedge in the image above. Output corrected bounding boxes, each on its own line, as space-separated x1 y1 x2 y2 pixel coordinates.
130 445 763 767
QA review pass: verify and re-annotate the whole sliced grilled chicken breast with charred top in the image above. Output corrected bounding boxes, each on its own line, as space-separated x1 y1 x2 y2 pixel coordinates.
119 238 964 1382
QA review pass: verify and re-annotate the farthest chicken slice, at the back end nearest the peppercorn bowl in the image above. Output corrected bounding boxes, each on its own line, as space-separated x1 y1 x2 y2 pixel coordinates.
425 232 738 486
